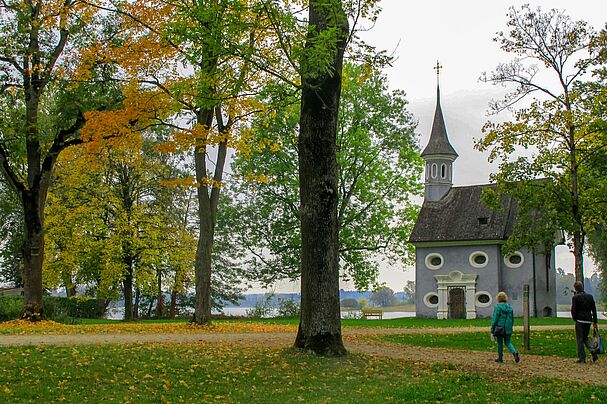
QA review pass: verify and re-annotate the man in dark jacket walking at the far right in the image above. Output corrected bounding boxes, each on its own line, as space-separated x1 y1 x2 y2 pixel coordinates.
571 281 599 363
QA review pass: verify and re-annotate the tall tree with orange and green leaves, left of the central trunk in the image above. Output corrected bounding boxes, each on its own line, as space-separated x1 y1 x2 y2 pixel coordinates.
102 0 289 324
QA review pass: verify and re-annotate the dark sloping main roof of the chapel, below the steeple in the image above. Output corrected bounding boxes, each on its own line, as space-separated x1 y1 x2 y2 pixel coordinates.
409 184 516 243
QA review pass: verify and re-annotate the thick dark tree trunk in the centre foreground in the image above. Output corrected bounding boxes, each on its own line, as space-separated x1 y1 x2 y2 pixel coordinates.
295 0 348 355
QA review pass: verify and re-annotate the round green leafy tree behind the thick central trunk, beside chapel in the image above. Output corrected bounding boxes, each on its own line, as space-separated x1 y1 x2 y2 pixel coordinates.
230 64 422 290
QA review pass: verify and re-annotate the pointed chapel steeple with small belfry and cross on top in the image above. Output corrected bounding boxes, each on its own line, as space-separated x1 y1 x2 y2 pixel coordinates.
421 61 458 202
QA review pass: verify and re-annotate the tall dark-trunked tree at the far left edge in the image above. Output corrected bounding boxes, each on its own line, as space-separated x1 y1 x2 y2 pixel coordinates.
0 0 119 318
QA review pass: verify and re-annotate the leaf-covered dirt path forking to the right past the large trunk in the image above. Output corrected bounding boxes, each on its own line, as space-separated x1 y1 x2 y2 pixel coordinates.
0 326 607 386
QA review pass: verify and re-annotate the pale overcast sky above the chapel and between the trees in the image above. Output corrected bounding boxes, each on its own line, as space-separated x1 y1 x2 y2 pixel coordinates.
268 0 607 291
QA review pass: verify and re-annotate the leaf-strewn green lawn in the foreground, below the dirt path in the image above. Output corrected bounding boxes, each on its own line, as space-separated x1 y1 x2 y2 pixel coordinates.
0 344 607 403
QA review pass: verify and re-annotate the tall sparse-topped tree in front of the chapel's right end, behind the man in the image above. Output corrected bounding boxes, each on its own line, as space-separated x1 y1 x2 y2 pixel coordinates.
476 5 605 280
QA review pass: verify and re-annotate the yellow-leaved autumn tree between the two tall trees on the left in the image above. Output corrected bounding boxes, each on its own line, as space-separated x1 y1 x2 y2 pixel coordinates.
44 133 195 320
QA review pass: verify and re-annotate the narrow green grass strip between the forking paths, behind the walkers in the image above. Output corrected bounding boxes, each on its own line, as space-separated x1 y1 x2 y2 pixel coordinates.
382 326 588 358
